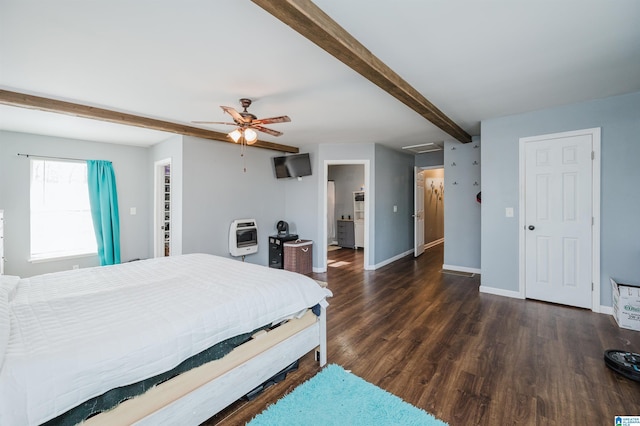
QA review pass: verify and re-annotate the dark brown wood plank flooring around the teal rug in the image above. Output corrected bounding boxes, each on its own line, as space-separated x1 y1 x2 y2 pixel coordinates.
205 245 640 426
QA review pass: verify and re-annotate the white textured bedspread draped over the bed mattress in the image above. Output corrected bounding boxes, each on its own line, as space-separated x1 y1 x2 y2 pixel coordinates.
0 254 331 425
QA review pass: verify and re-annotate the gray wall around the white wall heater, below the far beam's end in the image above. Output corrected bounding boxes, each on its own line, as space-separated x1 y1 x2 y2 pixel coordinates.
182 137 286 265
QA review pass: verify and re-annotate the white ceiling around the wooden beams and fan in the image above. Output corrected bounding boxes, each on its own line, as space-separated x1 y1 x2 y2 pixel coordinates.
0 0 640 150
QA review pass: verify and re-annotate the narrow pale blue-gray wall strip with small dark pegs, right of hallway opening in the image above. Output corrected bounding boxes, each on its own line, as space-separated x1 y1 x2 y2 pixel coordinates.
444 137 481 270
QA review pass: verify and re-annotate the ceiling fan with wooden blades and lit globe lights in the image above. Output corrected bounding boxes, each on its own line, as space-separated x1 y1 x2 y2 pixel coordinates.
193 98 291 145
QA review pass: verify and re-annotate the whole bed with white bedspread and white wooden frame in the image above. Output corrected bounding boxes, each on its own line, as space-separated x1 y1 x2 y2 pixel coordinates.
0 254 331 425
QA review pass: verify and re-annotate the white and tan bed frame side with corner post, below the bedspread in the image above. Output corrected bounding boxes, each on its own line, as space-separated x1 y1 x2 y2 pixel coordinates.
83 302 327 426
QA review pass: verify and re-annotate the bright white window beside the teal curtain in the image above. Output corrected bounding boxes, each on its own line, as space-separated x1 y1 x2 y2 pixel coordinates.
31 159 98 260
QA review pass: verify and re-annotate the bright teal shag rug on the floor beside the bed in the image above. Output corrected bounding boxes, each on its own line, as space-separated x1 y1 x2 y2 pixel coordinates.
248 364 446 426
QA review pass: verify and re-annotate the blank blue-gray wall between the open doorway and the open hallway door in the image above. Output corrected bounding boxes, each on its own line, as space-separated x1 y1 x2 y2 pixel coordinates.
373 144 415 264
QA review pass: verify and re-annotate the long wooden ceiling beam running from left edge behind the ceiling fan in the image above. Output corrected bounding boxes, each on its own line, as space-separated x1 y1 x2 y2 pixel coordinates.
0 89 299 153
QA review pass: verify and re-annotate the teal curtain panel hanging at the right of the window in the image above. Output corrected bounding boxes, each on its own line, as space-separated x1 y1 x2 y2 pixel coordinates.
87 160 120 266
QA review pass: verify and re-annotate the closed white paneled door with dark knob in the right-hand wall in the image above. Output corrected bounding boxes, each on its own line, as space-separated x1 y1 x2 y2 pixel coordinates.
524 134 593 308
